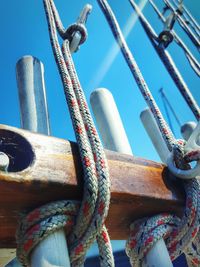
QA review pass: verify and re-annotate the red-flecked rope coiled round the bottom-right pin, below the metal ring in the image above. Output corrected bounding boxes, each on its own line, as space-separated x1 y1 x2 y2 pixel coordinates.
126 179 200 267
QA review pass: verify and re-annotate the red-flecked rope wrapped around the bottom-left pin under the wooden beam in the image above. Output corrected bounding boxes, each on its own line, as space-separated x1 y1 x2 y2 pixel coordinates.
16 200 80 267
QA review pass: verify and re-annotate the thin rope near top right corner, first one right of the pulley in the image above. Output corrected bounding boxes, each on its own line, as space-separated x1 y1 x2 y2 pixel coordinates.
163 0 200 50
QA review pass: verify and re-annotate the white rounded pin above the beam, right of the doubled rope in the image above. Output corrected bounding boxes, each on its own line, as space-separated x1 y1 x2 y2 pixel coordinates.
90 88 132 155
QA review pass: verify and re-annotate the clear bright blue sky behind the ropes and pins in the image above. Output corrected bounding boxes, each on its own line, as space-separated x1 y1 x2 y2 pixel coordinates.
0 0 200 264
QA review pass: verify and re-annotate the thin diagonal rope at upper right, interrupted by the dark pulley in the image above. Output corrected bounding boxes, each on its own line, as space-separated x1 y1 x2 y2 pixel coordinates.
149 0 200 76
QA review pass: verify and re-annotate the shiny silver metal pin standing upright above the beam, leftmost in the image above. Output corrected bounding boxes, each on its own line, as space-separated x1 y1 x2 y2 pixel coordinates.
16 56 50 134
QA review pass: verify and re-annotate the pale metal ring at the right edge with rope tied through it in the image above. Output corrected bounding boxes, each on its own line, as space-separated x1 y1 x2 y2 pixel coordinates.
167 152 200 179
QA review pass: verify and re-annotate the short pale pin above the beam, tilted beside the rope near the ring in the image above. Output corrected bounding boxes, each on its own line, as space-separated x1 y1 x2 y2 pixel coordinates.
140 108 169 163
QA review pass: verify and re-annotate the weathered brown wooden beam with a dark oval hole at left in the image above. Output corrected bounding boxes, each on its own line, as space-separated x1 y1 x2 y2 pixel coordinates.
0 125 184 248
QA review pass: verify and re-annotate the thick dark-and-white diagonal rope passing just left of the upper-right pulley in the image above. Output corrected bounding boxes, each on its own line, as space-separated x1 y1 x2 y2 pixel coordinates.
129 0 200 120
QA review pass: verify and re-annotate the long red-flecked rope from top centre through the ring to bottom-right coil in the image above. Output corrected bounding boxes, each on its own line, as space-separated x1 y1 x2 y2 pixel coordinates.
98 0 200 267
